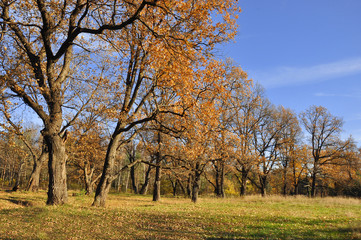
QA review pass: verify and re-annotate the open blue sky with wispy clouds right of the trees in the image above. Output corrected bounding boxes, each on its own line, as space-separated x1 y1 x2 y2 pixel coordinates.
221 0 361 142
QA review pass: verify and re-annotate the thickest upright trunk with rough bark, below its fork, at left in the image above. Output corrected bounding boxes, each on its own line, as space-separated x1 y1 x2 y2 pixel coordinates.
44 134 68 205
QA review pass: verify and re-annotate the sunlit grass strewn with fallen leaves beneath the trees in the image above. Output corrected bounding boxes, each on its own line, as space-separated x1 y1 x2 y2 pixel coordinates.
0 192 361 239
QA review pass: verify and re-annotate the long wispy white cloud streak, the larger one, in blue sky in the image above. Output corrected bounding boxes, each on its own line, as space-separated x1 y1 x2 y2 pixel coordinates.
253 58 361 88
